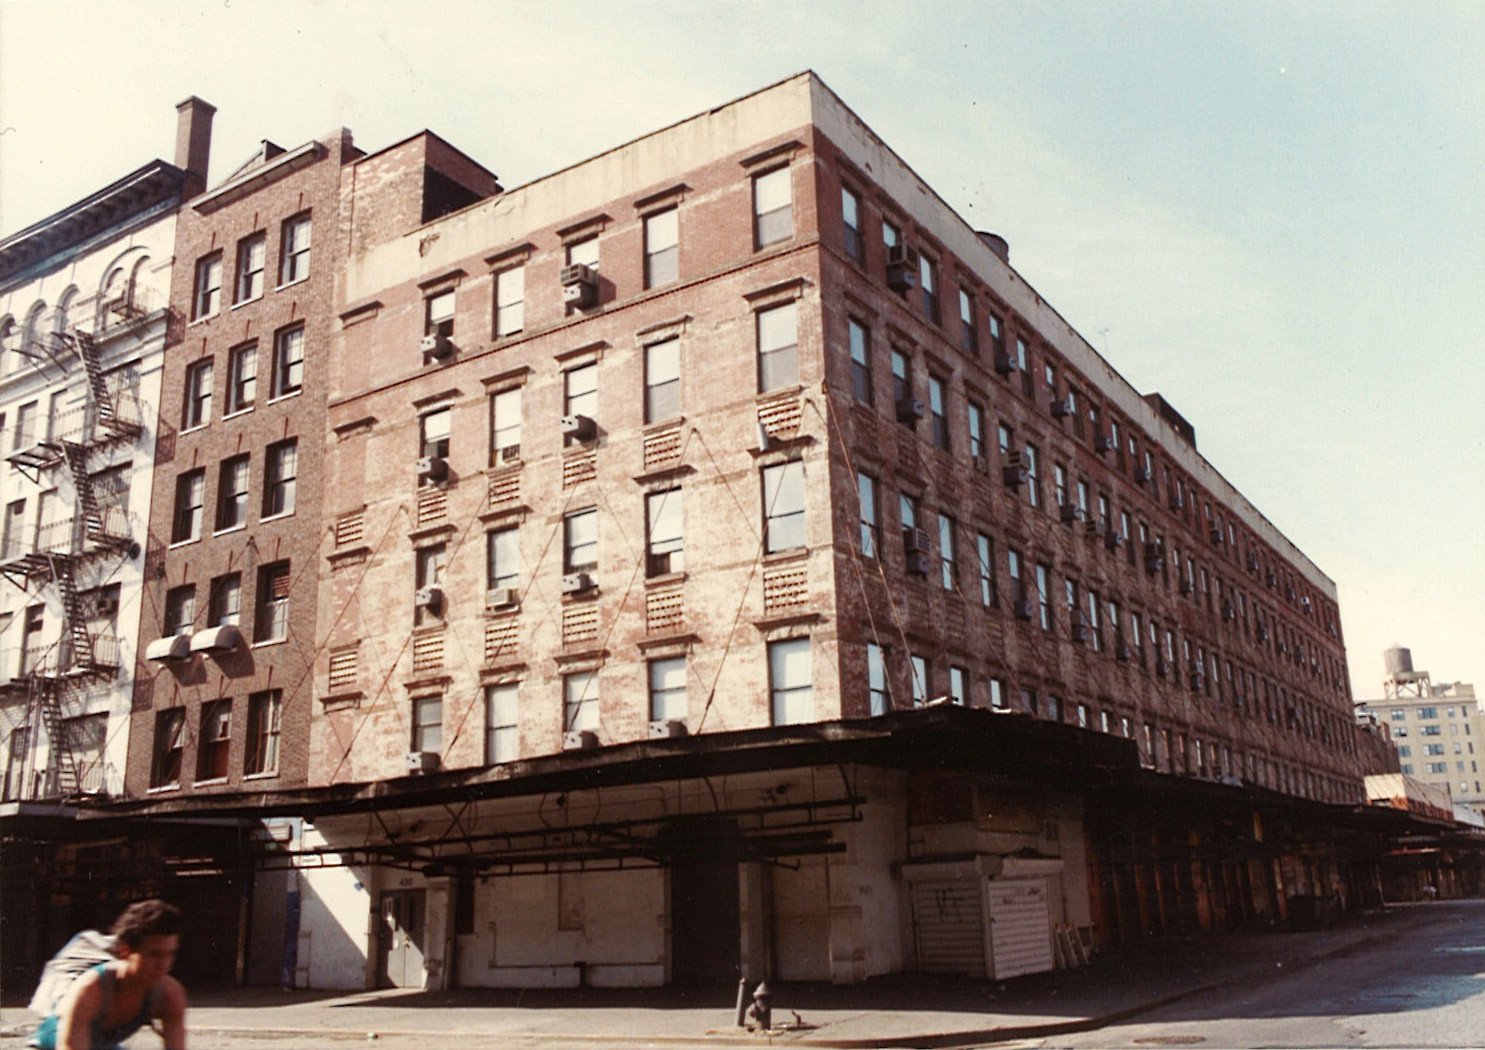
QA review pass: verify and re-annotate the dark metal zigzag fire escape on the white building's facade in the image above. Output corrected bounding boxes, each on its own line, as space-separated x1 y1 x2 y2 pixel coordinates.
0 328 143 798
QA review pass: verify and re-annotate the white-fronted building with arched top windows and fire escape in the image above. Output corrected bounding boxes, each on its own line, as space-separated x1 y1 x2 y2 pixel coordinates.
0 96 205 985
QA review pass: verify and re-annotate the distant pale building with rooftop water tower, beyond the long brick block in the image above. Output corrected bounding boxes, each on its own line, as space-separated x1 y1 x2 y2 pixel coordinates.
1357 646 1485 809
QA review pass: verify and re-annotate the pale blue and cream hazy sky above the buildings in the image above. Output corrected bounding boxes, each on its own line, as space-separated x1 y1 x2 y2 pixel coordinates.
0 0 1485 700
